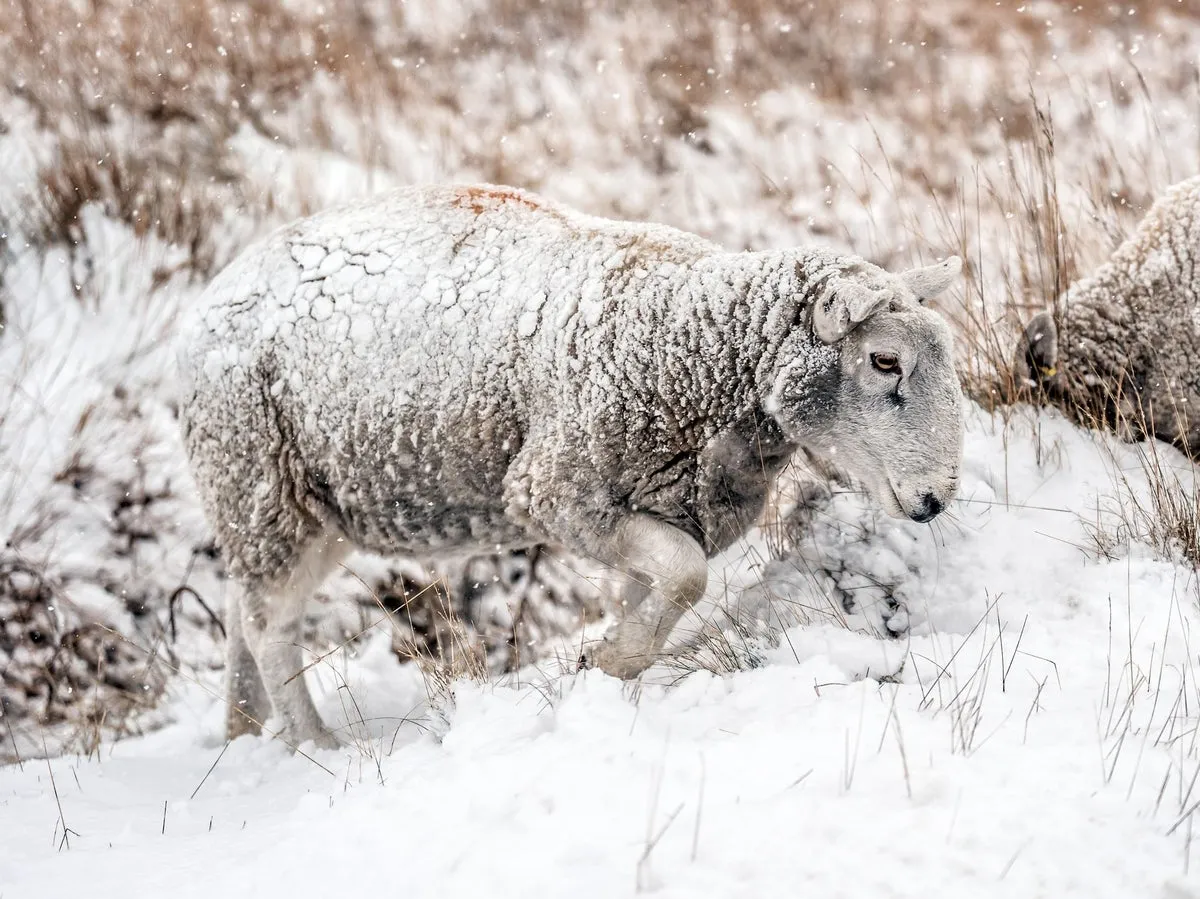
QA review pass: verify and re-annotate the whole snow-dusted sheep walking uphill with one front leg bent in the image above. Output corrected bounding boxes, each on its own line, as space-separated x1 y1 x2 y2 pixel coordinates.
179 185 964 747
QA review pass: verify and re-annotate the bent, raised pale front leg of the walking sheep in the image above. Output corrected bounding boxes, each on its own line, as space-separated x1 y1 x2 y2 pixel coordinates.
580 514 708 678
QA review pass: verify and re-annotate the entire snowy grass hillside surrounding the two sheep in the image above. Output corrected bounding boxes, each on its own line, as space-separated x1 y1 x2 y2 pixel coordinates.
7 0 1200 899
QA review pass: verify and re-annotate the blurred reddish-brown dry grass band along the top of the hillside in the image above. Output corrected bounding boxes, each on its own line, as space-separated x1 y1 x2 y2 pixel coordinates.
0 0 1171 276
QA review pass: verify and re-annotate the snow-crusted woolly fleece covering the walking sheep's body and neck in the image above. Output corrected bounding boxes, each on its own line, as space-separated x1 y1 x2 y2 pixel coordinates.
184 188 860 581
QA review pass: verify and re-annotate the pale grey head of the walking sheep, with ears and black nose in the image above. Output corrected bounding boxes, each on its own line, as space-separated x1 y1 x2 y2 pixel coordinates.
770 257 964 521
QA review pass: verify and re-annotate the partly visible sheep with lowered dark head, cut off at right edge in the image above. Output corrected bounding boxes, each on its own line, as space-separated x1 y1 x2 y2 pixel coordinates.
1013 176 1200 457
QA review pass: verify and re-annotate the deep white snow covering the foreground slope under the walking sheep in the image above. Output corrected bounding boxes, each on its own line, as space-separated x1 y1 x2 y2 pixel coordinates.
7 409 1200 899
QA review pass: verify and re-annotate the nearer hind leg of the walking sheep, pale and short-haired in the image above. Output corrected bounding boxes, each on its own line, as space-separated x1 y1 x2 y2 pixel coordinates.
241 535 349 749
